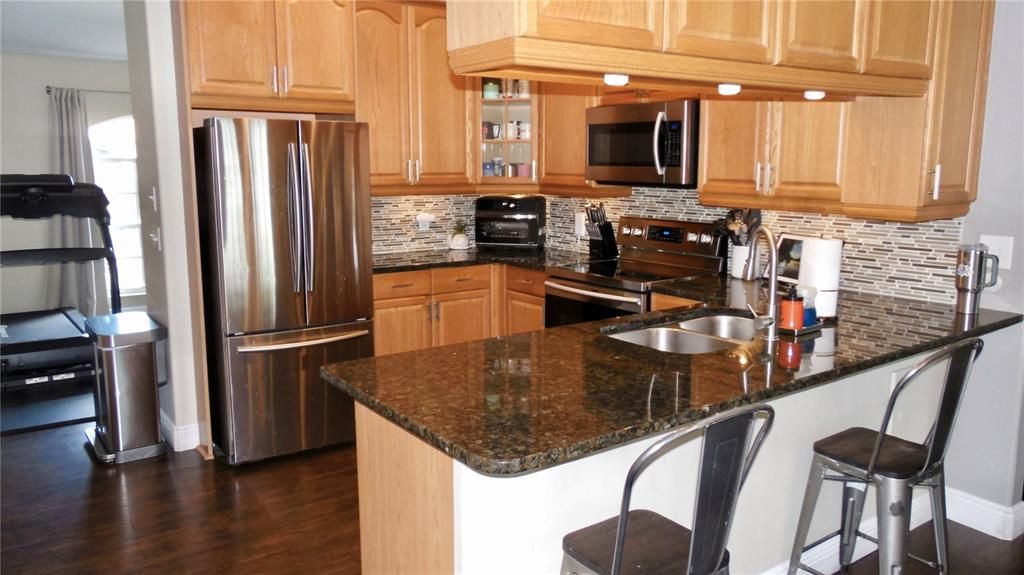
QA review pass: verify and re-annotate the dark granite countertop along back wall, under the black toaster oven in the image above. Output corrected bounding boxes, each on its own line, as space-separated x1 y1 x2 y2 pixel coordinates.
374 248 589 273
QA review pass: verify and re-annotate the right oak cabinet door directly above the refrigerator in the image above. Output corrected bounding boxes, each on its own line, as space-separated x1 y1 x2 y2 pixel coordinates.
278 0 355 101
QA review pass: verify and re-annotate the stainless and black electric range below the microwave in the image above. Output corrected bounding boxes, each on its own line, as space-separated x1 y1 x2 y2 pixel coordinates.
545 216 728 327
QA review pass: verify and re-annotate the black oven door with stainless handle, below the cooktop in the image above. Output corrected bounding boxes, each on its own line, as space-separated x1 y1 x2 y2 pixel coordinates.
544 278 648 327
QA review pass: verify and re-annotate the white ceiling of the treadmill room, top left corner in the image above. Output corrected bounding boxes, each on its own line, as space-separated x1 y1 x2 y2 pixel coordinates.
0 0 128 60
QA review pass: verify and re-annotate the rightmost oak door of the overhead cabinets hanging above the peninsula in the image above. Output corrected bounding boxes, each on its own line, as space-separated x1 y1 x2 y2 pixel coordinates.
864 0 939 78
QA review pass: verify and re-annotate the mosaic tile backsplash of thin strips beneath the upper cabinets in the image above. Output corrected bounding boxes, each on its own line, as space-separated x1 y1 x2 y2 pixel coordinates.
373 188 963 303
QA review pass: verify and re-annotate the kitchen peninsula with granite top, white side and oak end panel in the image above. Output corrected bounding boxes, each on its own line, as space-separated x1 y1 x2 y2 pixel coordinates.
323 270 1021 573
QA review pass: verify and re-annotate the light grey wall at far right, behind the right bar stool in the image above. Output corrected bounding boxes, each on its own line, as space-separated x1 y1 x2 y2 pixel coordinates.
949 0 1024 504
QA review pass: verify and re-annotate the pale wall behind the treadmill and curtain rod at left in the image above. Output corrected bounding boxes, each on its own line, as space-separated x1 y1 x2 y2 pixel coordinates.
0 52 131 312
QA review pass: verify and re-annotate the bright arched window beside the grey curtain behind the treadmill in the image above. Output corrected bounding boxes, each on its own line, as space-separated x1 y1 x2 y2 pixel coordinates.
89 116 145 296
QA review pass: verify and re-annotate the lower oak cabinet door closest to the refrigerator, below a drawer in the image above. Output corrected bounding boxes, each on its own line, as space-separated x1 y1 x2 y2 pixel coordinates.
374 296 432 356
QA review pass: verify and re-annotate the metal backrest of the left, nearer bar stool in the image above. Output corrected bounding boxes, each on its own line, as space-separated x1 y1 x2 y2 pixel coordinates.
611 404 775 575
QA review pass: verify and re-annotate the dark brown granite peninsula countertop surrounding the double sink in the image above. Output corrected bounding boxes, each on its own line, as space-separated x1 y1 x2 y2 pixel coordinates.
322 277 1021 476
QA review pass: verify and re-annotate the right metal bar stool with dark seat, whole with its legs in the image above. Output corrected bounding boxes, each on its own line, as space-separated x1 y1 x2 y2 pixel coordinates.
788 338 984 575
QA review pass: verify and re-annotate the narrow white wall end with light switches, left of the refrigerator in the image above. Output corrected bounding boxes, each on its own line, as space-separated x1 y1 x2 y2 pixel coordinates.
125 0 203 451
